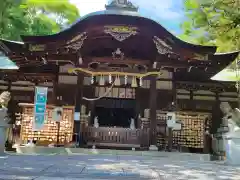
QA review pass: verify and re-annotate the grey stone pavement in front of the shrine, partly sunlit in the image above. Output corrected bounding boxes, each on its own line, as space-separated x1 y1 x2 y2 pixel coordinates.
0 155 240 180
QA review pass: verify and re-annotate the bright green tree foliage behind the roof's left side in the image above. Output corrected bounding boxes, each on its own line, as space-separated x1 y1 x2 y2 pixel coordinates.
0 0 79 41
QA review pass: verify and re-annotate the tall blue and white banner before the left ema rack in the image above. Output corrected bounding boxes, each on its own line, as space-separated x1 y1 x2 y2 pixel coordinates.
33 87 48 131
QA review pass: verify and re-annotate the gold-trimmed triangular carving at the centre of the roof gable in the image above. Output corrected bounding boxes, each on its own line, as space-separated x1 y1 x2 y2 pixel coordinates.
104 26 137 42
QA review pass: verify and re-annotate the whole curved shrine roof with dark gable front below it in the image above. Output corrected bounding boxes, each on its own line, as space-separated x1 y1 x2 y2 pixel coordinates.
0 0 239 81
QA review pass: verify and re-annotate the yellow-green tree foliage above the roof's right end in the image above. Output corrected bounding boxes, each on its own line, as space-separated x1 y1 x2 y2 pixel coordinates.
180 0 240 52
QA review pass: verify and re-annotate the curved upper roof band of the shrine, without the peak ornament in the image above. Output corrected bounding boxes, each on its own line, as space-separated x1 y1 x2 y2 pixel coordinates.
21 6 217 54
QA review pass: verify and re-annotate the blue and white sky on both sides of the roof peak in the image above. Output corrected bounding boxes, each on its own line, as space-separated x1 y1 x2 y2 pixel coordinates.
70 0 184 35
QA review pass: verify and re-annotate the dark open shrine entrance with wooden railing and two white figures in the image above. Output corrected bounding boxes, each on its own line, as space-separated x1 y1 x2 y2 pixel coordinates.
83 92 149 149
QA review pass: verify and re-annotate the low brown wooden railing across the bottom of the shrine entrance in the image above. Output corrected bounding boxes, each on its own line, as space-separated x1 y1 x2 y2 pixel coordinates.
82 127 149 148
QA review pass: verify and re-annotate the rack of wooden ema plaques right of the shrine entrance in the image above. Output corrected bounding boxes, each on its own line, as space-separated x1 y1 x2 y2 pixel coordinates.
157 112 209 148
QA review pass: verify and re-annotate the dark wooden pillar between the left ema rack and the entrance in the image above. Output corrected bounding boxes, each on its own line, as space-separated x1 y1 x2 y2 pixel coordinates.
75 73 84 145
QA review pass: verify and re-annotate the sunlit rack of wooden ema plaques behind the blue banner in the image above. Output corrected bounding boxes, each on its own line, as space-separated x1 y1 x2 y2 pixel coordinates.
20 104 74 145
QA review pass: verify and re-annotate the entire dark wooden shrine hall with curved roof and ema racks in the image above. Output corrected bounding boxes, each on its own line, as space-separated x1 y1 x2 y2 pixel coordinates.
0 0 238 152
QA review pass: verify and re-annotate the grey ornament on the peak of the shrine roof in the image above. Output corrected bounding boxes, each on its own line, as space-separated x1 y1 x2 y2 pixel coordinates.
105 0 138 12
